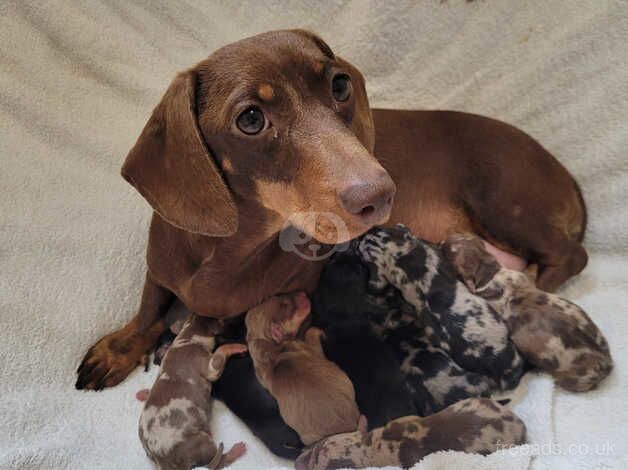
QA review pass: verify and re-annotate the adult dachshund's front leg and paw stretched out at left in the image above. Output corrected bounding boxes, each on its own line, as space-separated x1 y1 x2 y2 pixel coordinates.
76 273 174 390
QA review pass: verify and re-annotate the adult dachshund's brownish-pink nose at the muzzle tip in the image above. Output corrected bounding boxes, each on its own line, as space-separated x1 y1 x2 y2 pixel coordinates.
340 171 396 224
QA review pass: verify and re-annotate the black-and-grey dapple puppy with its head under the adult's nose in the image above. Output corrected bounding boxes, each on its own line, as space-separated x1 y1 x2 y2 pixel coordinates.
358 225 524 395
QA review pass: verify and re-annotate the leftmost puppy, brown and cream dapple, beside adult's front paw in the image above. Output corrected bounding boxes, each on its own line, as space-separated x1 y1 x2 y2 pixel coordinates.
139 315 246 470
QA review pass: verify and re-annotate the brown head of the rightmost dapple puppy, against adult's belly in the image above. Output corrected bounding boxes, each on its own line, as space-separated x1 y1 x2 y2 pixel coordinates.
441 233 501 292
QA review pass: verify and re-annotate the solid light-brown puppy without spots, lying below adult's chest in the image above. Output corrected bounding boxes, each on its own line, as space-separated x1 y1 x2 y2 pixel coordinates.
246 292 360 445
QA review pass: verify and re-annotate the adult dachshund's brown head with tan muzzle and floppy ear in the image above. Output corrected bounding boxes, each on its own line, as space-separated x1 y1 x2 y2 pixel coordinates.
122 30 395 243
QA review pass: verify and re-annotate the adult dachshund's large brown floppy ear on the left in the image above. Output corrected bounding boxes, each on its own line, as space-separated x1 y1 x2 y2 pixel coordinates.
122 70 238 237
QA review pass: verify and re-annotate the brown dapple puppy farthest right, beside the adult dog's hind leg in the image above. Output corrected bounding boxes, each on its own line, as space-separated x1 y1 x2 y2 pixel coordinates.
443 234 613 392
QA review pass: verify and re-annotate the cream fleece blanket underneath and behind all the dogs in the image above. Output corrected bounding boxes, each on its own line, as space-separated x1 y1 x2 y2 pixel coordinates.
0 0 628 470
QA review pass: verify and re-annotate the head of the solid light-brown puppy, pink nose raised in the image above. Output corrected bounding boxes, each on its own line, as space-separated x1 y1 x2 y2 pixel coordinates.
246 292 311 343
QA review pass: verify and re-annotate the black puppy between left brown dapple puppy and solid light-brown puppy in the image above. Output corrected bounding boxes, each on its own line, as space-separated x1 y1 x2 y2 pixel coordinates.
212 316 303 460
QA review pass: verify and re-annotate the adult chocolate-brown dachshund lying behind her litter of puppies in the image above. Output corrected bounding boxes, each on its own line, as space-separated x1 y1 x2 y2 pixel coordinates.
76 30 587 390
